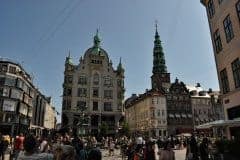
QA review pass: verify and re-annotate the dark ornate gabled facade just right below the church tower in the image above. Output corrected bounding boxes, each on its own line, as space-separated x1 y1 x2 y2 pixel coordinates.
167 78 193 135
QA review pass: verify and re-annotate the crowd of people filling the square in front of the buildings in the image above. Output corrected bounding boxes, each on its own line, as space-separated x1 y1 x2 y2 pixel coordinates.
0 133 221 160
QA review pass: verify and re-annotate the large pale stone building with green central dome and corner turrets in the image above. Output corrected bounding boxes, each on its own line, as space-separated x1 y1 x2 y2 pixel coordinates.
62 32 124 134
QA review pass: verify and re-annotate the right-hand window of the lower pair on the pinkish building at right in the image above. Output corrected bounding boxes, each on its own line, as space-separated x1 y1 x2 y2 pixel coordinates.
232 58 240 88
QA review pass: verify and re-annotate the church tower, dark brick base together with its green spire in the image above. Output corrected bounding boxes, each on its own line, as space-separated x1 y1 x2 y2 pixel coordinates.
151 24 170 92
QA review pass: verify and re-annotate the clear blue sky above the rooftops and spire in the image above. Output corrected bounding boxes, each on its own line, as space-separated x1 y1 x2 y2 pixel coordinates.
0 0 219 122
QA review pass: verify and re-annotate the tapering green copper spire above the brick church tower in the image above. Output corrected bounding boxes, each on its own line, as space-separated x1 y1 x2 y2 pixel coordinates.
152 23 167 74
